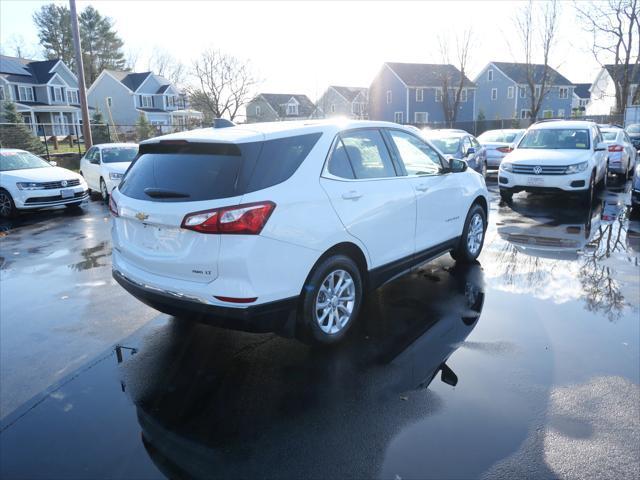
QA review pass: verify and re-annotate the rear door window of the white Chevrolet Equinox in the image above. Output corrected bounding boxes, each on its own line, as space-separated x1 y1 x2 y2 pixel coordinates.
340 130 396 179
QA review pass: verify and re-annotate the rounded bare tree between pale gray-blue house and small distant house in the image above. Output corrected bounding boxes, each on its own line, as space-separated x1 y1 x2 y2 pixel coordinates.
187 49 258 120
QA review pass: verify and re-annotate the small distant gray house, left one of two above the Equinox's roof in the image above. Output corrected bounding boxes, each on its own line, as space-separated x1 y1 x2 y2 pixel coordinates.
245 93 316 123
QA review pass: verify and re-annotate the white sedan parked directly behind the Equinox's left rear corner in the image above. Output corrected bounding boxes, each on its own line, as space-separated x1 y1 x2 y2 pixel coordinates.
80 143 138 201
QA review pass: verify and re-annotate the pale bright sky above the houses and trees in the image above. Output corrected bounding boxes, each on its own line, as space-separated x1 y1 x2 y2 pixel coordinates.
0 0 598 100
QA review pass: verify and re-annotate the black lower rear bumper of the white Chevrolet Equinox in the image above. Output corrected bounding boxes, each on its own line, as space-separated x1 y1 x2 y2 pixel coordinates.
112 268 298 332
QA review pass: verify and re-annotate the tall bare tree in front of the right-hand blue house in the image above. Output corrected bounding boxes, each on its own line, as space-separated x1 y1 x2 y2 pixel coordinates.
515 0 559 119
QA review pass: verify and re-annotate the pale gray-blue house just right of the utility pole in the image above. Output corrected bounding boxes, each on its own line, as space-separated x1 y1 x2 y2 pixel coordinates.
87 70 202 131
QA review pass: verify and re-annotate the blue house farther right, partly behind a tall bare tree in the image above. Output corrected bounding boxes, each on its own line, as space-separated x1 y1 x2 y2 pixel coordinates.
475 62 574 120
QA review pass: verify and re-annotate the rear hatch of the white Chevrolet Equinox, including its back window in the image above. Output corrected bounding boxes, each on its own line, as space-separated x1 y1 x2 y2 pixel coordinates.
114 142 261 283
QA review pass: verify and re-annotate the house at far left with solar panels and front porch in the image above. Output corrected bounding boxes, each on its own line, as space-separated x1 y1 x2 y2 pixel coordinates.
0 55 80 136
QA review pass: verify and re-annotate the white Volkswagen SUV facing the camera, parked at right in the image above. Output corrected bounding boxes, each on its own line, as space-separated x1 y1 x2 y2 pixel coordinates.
498 120 608 204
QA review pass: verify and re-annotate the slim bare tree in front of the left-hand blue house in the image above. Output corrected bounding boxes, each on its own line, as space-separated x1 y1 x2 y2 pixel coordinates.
438 29 473 123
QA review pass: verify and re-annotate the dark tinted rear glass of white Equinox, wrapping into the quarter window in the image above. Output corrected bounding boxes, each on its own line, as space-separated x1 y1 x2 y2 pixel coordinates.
118 133 322 202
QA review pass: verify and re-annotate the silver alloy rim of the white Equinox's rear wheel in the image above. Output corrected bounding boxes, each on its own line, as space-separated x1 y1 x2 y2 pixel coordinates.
315 270 356 335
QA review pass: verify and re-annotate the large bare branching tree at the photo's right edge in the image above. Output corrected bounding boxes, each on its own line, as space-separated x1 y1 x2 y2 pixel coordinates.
574 0 640 113
